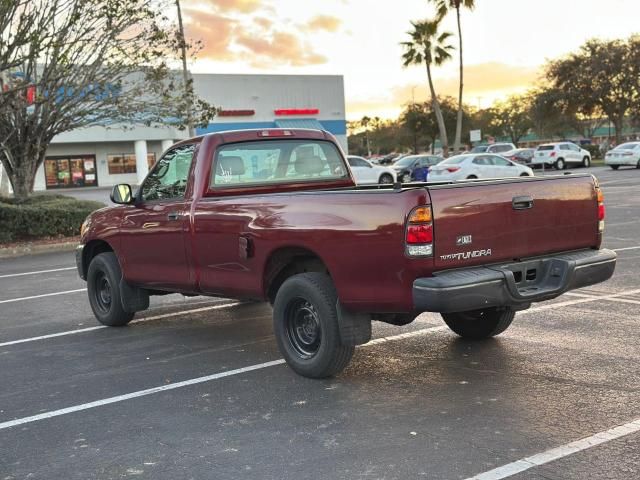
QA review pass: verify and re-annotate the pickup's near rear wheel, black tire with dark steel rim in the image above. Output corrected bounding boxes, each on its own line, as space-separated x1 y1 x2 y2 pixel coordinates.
273 272 355 378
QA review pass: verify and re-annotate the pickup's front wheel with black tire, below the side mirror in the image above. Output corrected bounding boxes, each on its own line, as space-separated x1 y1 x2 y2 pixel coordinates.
87 252 135 327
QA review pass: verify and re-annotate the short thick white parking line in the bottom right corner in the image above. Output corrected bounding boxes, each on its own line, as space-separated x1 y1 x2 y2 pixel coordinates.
466 418 640 480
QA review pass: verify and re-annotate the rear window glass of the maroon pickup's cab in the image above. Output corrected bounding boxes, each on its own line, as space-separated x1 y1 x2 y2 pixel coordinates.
210 140 348 187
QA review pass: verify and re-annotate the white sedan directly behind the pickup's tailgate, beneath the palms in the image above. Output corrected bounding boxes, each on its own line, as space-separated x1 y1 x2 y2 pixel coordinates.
429 153 533 182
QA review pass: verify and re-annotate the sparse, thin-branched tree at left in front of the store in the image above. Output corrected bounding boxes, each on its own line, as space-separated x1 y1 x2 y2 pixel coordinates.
0 0 216 199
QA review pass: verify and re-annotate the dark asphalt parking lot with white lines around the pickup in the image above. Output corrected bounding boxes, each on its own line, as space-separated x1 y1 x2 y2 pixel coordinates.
0 167 640 480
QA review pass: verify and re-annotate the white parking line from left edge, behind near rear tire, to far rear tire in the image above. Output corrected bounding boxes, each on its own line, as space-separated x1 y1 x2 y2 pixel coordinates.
0 325 447 430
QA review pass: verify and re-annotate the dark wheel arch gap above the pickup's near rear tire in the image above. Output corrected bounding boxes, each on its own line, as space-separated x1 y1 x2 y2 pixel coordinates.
263 246 331 303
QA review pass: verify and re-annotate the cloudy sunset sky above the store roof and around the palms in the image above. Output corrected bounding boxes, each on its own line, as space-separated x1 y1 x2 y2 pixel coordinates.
182 0 640 119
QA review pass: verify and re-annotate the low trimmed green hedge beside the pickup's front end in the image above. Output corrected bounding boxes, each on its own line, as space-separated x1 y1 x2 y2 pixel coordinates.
0 195 104 243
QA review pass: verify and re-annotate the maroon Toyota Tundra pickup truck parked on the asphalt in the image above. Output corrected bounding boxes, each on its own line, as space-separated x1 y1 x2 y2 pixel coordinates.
76 129 616 378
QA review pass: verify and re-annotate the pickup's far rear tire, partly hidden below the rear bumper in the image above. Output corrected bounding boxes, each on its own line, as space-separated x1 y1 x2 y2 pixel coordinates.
441 308 516 339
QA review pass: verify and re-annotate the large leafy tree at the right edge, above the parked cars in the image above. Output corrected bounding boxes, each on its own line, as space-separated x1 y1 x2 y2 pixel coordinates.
546 36 640 143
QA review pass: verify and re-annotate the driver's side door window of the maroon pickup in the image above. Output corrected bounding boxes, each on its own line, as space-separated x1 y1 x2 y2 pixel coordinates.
142 144 196 201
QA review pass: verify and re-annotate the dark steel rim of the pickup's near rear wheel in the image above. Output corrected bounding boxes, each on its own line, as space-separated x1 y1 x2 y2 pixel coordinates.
285 298 322 359
